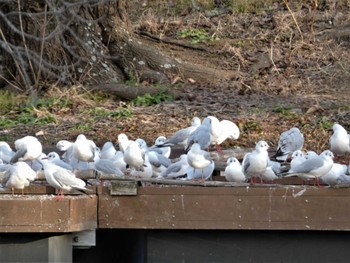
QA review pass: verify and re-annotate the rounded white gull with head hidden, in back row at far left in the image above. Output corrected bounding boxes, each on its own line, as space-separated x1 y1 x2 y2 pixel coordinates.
10 136 43 163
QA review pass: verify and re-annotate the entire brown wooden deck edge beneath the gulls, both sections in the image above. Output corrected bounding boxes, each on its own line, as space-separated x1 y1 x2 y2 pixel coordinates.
0 177 350 233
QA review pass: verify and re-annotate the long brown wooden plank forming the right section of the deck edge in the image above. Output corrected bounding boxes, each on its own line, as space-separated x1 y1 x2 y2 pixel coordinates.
98 186 350 230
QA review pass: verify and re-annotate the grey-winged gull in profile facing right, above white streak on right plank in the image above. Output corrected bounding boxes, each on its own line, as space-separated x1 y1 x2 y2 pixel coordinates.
285 150 334 186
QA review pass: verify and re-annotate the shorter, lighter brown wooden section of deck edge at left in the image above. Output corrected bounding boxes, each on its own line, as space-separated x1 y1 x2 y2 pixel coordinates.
0 195 97 232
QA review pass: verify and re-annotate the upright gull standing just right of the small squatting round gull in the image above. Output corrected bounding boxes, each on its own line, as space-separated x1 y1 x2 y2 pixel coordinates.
242 141 269 185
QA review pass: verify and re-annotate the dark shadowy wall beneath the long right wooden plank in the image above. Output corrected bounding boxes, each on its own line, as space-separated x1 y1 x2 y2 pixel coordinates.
73 229 350 263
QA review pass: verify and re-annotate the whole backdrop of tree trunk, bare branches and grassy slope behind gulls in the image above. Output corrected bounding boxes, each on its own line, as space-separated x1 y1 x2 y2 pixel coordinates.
0 0 350 157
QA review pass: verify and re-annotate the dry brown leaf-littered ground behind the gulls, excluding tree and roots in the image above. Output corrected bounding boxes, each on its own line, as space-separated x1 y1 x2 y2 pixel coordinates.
1 1 350 156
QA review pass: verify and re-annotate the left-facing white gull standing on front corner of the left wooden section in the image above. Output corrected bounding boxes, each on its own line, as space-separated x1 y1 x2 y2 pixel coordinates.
40 158 90 200
